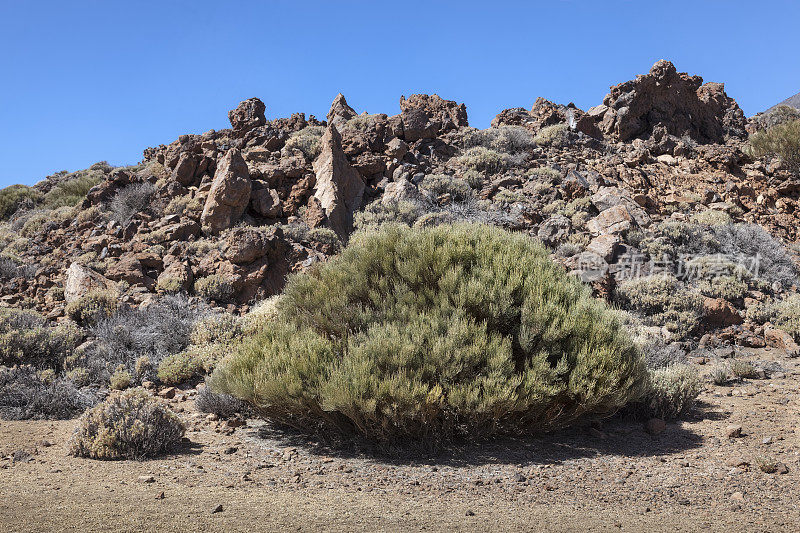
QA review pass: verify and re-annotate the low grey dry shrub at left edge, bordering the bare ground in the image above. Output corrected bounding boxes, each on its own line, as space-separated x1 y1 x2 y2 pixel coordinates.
0 365 95 420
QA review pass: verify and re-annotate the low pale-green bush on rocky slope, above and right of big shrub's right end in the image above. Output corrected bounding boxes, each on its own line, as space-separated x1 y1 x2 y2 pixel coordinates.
616 275 702 337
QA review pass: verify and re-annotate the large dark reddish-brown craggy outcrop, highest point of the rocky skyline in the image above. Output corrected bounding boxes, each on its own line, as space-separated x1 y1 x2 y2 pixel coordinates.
589 60 747 143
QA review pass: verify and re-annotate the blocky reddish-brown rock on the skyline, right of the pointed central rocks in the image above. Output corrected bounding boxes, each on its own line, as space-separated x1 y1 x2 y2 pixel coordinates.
400 94 469 142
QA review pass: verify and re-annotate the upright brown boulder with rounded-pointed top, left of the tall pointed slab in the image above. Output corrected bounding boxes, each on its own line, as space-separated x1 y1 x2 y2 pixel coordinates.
200 148 252 233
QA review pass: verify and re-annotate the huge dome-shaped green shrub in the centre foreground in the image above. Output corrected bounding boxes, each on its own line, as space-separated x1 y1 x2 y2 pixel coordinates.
210 225 646 445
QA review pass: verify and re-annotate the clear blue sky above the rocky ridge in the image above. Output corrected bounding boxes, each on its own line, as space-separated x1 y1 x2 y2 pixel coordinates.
0 0 800 186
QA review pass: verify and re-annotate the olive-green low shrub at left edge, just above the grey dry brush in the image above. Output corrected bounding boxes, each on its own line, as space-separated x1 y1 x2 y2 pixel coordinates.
0 308 82 368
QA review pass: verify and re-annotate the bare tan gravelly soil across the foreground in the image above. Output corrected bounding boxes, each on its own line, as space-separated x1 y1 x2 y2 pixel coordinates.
0 350 800 532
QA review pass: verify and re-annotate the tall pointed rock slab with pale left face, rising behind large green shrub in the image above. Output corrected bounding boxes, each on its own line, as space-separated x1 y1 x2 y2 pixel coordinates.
314 124 364 239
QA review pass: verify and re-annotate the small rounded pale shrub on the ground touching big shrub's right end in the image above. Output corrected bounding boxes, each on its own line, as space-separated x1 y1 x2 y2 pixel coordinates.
643 365 703 420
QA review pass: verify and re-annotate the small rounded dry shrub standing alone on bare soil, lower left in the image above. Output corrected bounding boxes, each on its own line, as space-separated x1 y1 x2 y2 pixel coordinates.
70 389 186 460
